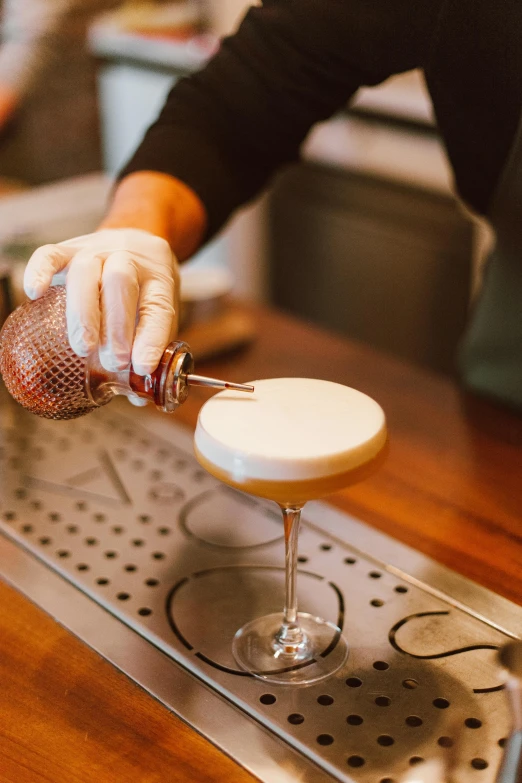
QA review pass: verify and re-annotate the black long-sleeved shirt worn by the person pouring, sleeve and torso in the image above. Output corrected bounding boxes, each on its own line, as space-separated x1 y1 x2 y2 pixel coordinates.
122 0 522 236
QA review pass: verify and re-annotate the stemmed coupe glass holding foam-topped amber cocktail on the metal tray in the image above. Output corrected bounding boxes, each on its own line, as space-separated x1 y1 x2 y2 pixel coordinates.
194 378 387 684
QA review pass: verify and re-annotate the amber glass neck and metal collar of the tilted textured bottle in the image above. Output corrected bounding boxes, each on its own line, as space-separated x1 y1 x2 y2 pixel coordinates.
85 342 194 413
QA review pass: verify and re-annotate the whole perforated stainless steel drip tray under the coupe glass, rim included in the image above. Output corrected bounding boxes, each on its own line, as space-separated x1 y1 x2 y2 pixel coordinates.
0 403 522 783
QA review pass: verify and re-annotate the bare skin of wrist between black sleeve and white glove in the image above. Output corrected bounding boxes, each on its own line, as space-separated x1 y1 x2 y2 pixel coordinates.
99 171 207 261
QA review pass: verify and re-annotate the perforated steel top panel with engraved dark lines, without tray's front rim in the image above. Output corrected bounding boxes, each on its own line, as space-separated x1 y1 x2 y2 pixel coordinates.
0 410 509 783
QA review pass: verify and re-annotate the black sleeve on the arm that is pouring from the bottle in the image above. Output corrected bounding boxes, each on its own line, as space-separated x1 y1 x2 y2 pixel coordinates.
120 0 443 238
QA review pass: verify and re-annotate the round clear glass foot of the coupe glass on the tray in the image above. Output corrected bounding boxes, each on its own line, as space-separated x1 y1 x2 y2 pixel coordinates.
232 612 348 685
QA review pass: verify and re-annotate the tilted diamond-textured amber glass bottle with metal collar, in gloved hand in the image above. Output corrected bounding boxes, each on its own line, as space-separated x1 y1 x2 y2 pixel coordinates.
0 286 193 419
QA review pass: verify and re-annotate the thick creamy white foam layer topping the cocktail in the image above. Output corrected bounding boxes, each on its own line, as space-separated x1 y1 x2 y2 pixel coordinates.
194 378 386 481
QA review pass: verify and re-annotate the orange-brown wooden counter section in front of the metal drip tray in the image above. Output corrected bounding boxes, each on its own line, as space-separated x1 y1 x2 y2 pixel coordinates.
0 581 253 783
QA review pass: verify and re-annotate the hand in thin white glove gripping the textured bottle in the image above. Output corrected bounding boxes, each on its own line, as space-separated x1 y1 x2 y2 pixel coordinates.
24 228 179 375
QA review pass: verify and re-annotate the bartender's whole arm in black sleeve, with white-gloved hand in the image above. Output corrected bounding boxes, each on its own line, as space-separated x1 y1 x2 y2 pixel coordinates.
25 0 442 373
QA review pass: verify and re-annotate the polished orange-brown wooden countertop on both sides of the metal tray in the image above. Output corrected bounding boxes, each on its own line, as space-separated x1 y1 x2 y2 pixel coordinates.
0 308 522 783
